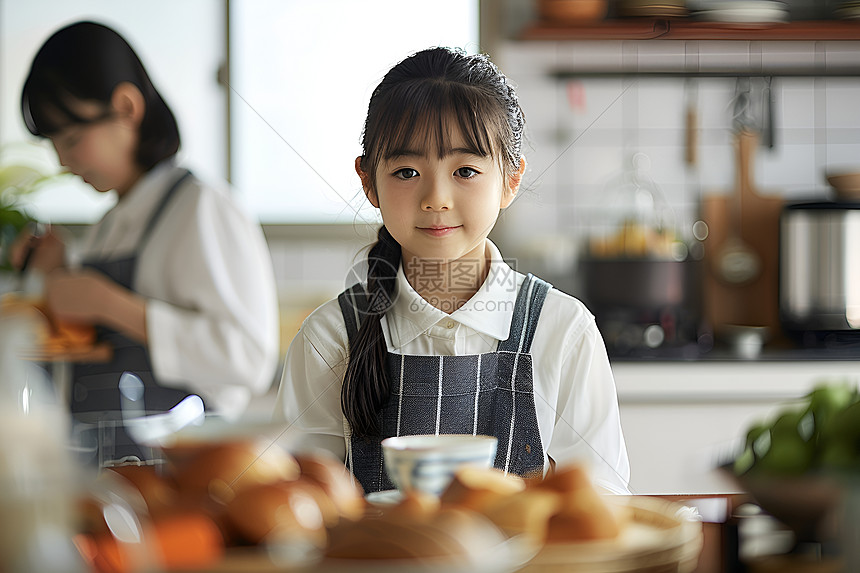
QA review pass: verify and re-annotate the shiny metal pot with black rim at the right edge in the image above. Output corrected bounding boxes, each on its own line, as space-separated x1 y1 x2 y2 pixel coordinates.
779 202 860 332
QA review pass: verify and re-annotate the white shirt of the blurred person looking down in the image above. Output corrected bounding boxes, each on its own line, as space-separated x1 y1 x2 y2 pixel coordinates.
80 162 279 418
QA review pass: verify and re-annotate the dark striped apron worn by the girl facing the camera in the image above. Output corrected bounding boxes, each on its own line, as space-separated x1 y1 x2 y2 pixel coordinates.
338 275 550 493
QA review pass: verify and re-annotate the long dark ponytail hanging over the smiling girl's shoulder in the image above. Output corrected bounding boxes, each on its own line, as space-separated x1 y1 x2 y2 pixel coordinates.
340 225 401 437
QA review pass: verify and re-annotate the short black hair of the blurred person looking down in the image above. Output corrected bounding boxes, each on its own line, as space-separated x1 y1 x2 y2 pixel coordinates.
21 22 180 171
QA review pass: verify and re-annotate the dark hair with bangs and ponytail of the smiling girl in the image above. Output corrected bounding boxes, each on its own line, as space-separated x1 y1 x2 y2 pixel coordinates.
341 48 525 437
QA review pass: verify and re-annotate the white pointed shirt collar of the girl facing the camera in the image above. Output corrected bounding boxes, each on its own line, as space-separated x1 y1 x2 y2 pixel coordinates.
382 239 522 349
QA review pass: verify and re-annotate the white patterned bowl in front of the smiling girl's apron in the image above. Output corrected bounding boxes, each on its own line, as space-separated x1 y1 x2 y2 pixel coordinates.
382 434 499 495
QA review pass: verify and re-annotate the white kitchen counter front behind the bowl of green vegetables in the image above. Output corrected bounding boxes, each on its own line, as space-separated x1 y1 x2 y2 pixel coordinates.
612 359 860 494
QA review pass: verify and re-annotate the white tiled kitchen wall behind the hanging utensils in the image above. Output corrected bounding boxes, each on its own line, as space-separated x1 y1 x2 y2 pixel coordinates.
493 41 860 281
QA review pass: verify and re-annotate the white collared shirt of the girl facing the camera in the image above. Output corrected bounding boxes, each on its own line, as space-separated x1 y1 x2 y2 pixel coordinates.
275 240 630 493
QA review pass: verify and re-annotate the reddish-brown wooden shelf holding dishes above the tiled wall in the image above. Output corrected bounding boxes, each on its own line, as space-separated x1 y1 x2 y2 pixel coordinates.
520 18 860 41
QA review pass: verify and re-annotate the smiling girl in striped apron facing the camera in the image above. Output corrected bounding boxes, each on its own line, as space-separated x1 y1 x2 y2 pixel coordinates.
276 48 630 493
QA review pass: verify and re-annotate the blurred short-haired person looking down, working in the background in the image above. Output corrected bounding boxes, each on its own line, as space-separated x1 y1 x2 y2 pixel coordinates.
18 22 278 452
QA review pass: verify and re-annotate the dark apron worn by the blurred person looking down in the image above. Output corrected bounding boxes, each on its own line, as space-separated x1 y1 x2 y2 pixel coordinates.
70 171 199 459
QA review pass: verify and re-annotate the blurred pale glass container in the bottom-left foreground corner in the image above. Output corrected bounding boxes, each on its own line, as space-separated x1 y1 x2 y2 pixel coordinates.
0 314 85 573
